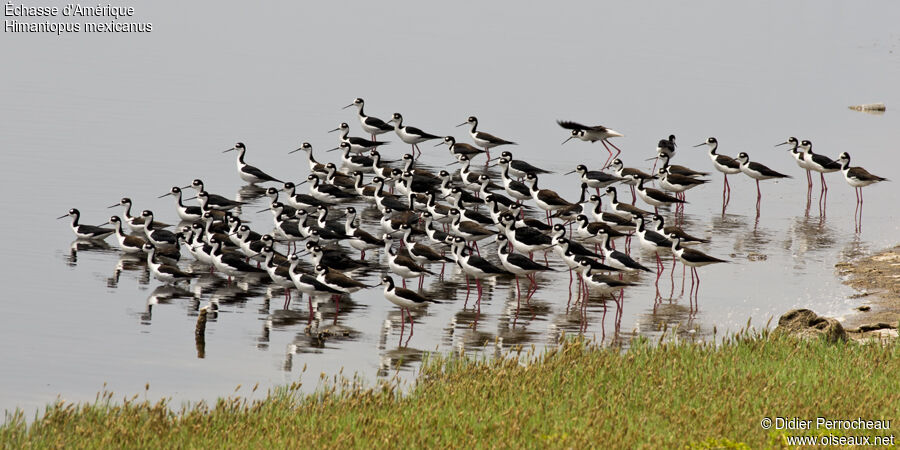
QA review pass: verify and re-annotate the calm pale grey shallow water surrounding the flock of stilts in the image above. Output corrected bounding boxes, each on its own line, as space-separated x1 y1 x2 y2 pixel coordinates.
0 1 900 418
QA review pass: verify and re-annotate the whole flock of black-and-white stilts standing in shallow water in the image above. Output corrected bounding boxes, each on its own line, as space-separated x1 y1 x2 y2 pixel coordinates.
60 98 885 338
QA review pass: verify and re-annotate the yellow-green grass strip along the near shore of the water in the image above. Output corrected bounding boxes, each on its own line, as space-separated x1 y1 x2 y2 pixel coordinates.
0 333 900 448
